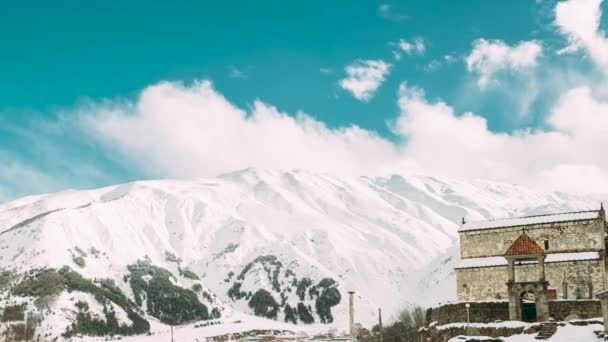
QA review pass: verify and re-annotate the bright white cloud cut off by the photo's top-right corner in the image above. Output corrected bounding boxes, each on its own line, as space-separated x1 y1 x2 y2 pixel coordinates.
555 0 608 66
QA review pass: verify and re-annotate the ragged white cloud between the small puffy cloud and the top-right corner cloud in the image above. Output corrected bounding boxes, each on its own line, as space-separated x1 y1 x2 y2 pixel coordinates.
465 39 542 87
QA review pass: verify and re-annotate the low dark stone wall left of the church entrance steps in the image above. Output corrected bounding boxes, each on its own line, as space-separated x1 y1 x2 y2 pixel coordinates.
426 302 509 325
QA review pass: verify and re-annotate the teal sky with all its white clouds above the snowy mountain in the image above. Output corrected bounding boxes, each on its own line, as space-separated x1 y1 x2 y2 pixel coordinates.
0 0 608 202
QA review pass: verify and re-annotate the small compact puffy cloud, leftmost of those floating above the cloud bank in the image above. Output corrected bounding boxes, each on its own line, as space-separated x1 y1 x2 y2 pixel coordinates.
340 60 391 102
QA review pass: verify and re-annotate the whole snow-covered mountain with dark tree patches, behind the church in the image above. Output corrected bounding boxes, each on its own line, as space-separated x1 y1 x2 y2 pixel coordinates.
0 169 599 335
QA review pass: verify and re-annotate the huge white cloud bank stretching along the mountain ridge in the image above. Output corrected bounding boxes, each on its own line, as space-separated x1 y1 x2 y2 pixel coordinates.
81 81 608 193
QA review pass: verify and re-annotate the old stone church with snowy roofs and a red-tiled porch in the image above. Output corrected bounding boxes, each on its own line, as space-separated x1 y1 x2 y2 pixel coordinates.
456 206 607 321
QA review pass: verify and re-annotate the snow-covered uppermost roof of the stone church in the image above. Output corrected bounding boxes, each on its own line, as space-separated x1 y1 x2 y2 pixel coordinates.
458 210 600 232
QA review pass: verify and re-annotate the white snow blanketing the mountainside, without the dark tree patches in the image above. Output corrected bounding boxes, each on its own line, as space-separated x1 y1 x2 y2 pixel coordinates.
0 169 599 331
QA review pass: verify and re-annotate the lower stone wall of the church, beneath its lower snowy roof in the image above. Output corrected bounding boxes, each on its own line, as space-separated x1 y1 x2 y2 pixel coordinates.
456 260 604 302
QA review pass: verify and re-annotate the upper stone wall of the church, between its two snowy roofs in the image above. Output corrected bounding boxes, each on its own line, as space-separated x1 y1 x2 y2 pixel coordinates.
460 219 604 258
